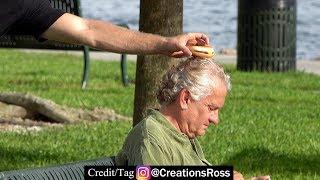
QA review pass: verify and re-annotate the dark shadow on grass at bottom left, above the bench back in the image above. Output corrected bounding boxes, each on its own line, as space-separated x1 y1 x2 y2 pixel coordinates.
0 146 66 172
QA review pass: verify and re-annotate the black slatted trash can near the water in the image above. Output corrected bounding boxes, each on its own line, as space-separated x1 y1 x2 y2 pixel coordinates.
237 0 297 72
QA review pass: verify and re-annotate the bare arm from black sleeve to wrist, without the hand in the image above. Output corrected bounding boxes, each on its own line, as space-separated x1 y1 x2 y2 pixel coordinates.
42 13 170 54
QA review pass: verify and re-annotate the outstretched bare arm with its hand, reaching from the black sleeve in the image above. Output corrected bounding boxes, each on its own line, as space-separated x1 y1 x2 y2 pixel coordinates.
42 13 209 57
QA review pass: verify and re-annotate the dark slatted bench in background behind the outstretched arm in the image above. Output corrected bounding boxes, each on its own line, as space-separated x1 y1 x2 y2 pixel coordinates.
0 0 128 89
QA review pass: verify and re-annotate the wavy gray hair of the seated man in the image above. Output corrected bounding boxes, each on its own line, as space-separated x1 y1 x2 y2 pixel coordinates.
157 58 231 105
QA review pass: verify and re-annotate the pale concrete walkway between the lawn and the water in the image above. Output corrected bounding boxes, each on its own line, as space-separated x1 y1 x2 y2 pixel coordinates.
21 49 320 75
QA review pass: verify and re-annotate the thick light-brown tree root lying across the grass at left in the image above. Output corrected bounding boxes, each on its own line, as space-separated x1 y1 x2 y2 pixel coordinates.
0 93 130 126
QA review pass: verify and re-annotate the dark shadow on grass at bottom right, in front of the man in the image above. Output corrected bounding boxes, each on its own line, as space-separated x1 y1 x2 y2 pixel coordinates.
223 148 320 174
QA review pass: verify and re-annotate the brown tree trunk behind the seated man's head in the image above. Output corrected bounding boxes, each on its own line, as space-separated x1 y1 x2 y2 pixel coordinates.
133 0 183 126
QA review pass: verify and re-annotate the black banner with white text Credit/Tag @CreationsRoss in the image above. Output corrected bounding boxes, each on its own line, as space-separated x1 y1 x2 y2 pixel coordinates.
84 165 233 180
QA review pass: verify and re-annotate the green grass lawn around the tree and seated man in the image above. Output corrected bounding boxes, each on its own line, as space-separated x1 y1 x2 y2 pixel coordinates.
0 50 320 179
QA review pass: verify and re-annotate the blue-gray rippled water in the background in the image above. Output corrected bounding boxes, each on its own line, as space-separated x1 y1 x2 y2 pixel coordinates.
81 0 320 59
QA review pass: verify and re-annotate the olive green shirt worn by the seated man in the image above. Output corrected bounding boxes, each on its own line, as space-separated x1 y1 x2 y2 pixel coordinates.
116 109 210 165
